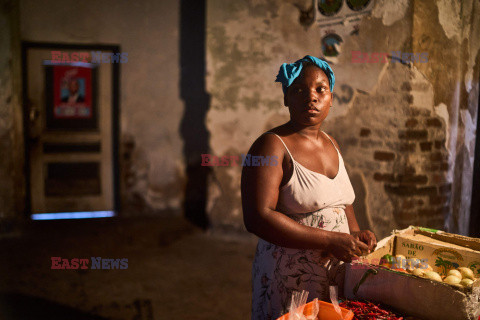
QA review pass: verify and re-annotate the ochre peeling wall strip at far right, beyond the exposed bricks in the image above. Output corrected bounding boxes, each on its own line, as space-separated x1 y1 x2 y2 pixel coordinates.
412 0 480 234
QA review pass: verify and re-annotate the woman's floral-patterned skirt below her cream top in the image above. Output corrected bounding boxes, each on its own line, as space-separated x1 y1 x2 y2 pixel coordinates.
252 208 349 320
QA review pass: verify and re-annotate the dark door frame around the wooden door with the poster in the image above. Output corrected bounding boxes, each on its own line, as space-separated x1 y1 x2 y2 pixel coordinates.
21 41 121 219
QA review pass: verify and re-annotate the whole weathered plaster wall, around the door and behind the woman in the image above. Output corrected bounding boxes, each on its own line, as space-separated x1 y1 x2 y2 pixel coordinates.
0 0 480 237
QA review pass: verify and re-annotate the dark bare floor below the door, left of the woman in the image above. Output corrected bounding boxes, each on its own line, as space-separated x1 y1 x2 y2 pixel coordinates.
0 217 256 320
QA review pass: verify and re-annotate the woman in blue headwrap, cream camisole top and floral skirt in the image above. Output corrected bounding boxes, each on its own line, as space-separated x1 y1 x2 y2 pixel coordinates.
242 56 376 320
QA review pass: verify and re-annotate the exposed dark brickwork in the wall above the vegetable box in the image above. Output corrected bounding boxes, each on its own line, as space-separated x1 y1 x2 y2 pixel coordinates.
373 107 451 228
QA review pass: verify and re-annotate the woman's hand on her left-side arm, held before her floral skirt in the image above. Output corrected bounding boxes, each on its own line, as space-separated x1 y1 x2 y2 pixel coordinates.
326 232 368 262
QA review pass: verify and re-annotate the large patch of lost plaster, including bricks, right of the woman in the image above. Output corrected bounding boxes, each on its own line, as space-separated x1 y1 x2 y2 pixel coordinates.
325 64 451 237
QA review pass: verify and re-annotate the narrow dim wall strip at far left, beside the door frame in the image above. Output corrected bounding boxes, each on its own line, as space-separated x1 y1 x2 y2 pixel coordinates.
0 0 24 235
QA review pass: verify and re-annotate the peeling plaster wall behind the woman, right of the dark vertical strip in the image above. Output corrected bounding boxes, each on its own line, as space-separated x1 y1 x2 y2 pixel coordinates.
207 0 480 238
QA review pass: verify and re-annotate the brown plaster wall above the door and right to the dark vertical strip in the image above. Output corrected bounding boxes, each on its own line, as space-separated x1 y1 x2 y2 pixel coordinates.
20 0 185 215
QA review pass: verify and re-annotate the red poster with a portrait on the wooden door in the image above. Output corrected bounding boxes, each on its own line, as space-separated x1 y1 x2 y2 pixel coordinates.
45 63 98 130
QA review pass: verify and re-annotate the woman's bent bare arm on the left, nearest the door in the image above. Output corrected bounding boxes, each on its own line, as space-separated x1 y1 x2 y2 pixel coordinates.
241 134 367 261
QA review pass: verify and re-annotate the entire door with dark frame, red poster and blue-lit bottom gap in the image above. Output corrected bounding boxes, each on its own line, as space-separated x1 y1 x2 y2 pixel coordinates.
22 42 121 220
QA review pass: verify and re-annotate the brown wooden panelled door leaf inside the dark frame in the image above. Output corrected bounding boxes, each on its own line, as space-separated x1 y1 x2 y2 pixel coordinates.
26 48 114 213
